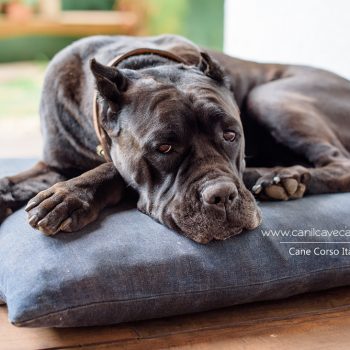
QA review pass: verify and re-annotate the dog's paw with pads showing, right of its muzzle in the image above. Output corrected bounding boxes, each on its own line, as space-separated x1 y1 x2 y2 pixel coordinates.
252 166 310 200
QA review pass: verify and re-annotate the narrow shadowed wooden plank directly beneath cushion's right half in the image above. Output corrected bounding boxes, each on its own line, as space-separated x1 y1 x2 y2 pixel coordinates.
134 287 350 338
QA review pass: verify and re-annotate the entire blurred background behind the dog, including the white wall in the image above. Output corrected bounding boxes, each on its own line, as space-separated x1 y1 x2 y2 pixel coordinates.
0 0 350 157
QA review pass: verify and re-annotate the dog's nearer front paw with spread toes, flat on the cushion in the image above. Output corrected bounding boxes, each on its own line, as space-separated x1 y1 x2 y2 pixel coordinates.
26 181 98 236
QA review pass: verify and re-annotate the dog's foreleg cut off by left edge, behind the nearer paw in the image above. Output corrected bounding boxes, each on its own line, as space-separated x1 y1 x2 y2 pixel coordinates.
0 162 66 222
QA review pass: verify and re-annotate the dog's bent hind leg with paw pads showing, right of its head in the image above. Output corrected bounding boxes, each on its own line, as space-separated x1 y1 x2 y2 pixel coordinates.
244 71 350 200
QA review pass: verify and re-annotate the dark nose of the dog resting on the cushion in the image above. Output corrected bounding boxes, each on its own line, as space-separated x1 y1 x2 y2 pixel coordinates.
202 182 237 206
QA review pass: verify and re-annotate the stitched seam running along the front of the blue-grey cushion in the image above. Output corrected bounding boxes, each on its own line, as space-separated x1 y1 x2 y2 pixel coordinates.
15 265 350 325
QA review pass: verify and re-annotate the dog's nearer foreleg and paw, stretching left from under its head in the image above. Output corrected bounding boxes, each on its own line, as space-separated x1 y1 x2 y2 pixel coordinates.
26 163 125 235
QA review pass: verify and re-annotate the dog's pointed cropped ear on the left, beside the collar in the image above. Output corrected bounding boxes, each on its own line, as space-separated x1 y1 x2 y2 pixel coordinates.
90 58 129 103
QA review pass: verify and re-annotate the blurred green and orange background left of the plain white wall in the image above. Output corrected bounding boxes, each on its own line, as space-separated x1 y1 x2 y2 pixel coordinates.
0 0 224 157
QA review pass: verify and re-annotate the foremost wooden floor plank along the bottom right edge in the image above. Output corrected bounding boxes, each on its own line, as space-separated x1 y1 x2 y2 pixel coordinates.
76 311 350 350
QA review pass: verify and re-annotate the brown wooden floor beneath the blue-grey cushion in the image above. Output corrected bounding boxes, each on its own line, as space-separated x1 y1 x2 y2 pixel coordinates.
0 287 350 350
